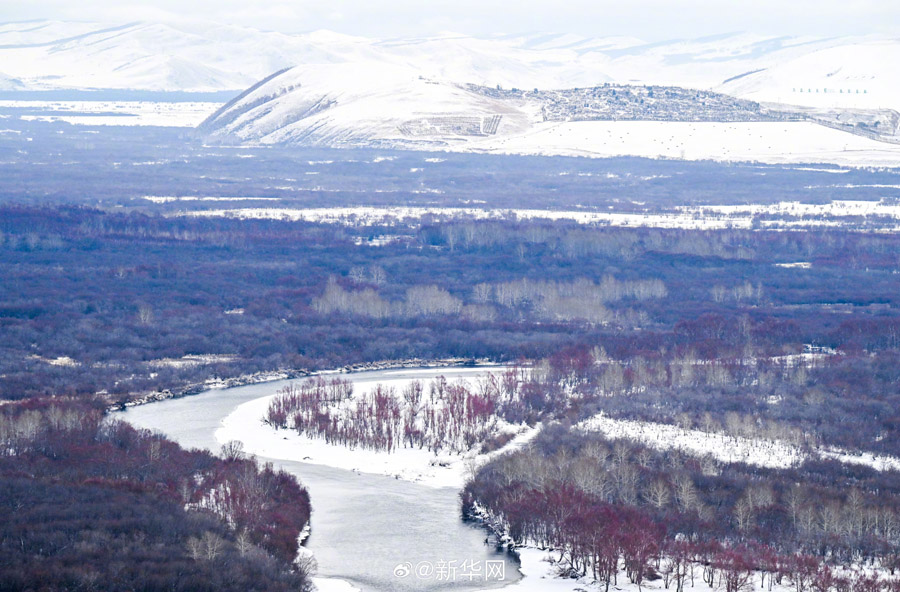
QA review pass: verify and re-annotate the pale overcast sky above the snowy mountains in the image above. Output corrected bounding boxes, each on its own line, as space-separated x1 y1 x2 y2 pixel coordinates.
0 0 900 41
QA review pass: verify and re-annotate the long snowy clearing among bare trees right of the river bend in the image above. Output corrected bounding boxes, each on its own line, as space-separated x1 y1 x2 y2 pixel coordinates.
578 413 900 471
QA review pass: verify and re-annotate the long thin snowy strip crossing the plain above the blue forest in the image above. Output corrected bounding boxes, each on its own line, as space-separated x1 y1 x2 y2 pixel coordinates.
178 197 900 232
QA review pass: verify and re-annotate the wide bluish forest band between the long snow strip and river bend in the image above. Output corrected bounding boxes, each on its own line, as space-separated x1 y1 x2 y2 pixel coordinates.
0 206 900 401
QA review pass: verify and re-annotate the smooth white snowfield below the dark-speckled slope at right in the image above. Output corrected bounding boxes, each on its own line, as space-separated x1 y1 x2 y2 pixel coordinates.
472 121 900 167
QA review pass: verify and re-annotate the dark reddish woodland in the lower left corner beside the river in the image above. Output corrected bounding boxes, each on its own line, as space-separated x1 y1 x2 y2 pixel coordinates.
0 399 311 592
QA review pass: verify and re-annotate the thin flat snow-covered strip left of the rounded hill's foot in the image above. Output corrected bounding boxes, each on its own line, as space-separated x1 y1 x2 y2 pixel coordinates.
0 100 222 127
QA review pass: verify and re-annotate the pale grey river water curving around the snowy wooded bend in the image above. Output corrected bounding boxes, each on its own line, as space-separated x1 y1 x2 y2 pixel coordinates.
122 368 520 592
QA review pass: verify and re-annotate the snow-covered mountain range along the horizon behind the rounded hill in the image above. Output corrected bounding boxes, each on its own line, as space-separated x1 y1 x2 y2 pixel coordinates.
0 21 900 114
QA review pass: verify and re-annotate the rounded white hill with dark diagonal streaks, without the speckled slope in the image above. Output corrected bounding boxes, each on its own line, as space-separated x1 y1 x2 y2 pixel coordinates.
201 64 539 148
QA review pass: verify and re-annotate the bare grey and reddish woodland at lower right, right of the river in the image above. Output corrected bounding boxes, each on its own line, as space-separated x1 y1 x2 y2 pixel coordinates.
461 424 900 592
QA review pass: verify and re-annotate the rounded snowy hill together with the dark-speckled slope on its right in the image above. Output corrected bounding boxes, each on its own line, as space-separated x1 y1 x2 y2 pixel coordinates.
200 64 774 149
